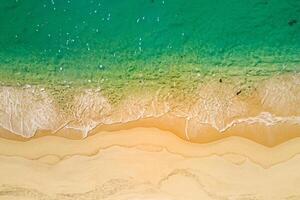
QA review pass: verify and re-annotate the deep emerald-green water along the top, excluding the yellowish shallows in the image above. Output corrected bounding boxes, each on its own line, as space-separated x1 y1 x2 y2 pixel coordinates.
0 0 300 55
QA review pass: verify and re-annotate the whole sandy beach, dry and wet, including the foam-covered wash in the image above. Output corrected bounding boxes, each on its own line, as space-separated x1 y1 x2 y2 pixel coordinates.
0 74 300 200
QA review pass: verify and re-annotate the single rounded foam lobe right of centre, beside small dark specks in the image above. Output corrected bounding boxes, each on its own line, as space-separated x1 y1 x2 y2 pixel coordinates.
187 83 249 138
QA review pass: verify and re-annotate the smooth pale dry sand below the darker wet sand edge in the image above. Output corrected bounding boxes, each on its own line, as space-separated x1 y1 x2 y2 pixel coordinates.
0 128 300 200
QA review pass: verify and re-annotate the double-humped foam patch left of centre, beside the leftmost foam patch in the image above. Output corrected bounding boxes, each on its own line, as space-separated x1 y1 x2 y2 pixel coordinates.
65 89 168 137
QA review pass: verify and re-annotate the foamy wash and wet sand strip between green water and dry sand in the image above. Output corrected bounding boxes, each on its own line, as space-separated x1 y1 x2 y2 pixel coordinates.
0 71 300 147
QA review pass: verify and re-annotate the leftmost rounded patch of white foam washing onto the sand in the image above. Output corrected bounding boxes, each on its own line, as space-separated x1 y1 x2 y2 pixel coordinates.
0 86 60 137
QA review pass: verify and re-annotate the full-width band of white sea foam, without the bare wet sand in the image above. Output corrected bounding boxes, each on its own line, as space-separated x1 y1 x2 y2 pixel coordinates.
0 78 300 139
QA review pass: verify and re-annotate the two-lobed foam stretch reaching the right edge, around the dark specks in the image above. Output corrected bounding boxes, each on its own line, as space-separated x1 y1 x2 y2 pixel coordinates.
181 76 300 140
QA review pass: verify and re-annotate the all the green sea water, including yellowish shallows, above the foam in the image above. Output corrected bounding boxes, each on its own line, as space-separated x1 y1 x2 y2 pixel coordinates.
0 0 300 94
